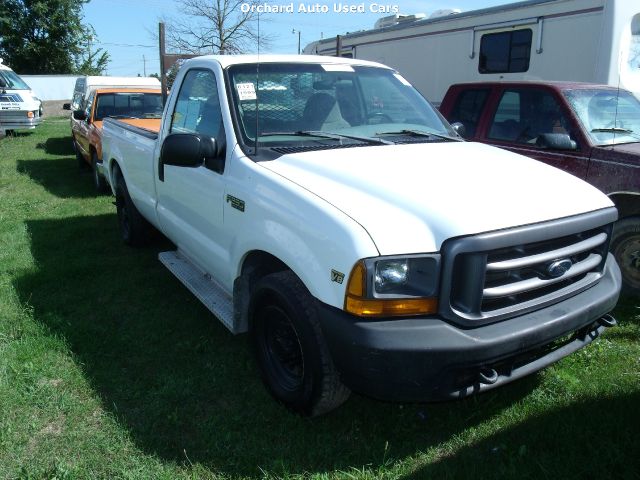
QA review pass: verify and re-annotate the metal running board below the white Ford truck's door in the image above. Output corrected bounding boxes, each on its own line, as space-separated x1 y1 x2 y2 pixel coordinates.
158 250 239 333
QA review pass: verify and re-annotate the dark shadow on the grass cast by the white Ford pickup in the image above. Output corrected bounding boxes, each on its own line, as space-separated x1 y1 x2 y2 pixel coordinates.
15 217 560 477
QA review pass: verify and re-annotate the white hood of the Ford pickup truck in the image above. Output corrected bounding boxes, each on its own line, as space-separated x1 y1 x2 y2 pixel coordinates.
261 142 613 255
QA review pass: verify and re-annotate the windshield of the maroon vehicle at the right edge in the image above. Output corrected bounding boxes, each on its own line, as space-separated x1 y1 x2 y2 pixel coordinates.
563 88 640 145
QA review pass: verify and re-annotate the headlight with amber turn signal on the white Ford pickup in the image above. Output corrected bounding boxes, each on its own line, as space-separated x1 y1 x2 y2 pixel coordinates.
345 254 440 317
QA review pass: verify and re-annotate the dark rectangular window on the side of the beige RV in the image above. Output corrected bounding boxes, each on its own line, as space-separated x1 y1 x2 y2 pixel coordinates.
478 28 532 73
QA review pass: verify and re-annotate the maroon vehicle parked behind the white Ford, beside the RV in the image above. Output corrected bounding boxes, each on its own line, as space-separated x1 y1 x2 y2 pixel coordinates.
440 82 640 295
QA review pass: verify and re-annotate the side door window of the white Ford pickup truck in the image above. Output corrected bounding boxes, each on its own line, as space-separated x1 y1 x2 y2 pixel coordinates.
169 70 222 138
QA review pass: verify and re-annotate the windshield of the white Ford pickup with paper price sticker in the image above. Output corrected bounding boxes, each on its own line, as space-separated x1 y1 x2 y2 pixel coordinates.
228 63 456 147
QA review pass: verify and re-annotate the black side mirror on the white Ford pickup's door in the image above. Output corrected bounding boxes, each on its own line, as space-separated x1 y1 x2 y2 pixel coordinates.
158 133 224 181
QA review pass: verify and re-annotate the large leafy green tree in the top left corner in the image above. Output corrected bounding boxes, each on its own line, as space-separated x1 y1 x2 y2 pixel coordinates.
0 0 109 74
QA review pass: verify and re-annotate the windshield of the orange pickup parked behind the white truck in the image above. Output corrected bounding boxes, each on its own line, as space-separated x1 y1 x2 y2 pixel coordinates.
94 92 162 120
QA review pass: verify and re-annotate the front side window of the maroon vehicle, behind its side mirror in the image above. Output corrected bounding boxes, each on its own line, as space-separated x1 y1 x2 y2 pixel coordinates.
489 89 574 145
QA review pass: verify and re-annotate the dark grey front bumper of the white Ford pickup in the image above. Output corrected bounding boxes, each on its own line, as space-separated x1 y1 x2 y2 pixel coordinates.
320 255 621 401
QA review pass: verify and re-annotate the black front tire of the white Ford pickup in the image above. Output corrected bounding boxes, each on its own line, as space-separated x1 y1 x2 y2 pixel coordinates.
250 271 350 416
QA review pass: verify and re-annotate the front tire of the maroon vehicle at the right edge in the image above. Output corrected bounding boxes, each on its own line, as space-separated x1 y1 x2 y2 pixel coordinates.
611 217 640 296
